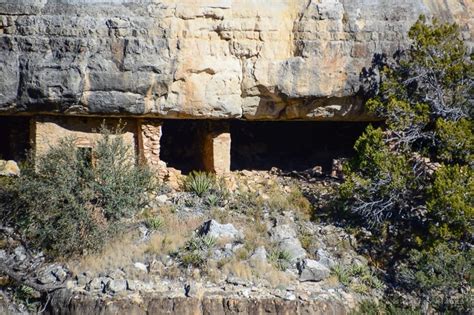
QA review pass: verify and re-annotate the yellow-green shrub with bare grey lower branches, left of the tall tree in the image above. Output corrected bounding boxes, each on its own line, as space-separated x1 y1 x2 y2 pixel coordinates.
339 126 420 227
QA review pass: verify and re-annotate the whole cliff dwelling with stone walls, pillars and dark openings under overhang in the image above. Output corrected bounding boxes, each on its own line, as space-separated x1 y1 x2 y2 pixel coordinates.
0 116 367 174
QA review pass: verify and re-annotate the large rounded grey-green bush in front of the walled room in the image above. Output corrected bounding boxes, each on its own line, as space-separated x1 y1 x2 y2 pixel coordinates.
1 130 154 256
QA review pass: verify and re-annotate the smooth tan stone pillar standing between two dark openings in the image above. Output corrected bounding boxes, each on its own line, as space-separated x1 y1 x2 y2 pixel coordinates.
203 122 231 175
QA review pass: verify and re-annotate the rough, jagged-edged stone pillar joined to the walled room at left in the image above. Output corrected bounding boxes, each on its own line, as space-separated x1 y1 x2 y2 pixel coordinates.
138 120 166 168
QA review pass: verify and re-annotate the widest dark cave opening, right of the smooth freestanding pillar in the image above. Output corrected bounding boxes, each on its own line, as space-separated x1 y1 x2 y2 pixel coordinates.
230 121 368 172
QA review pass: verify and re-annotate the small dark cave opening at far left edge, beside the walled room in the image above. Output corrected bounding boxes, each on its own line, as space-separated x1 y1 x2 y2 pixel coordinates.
0 116 30 161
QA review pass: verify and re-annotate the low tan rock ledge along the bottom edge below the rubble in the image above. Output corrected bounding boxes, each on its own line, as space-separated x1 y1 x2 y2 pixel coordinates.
46 292 349 315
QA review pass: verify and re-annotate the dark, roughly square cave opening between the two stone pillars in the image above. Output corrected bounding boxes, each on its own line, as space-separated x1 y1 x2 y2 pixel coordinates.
160 119 207 174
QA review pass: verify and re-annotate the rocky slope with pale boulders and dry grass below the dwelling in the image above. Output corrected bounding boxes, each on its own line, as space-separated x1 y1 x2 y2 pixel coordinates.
0 171 384 314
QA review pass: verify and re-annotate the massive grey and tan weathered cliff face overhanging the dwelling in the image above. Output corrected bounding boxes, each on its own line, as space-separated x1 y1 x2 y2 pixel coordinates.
0 0 474 120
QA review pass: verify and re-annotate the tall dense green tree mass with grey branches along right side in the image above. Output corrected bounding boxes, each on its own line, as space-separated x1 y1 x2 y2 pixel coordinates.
337 17 474 312
